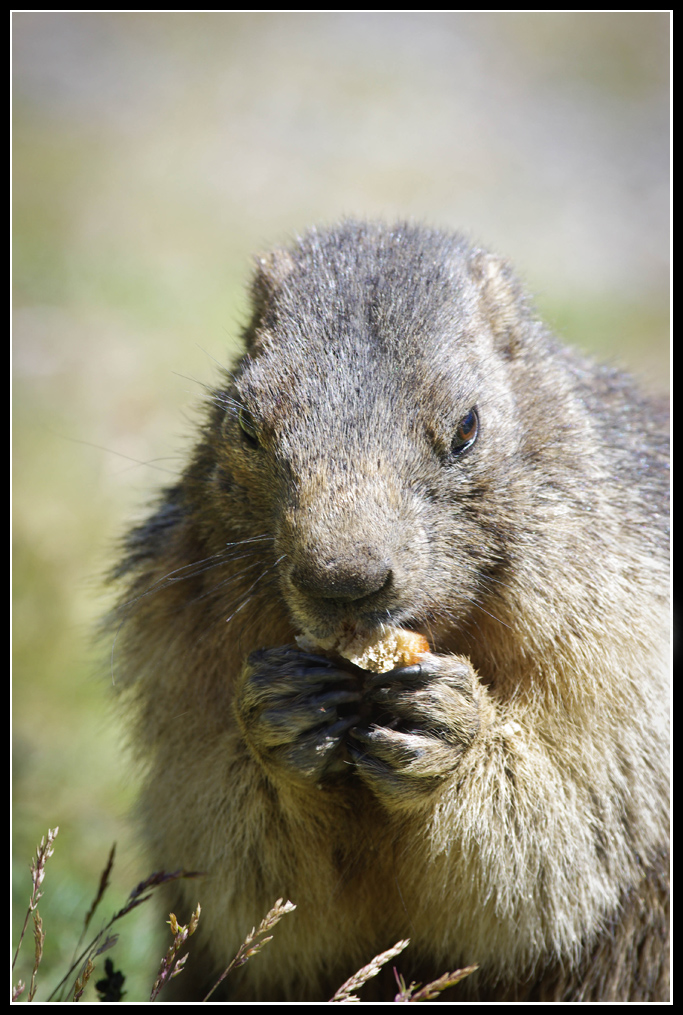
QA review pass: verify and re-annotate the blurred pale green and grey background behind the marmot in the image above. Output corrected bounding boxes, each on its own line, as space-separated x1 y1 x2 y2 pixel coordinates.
12 11 669 1000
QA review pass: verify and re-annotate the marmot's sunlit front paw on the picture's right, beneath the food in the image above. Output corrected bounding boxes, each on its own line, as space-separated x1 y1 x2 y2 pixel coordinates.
348 653 479 803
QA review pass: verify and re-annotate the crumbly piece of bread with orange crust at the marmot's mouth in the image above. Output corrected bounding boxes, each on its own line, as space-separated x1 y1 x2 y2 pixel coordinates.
296 627 429 673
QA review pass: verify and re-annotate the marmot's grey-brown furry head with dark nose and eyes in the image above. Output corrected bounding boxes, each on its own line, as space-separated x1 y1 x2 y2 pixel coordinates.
208 222 580 636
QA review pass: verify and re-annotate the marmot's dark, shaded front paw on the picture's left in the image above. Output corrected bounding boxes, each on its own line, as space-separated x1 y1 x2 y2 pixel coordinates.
235 646 360 782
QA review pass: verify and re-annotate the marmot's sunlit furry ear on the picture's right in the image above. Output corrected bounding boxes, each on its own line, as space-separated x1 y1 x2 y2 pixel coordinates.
469 250 531 359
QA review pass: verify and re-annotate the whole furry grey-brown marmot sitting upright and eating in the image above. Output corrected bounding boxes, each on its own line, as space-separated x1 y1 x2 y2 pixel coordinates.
109 221 669 1001
